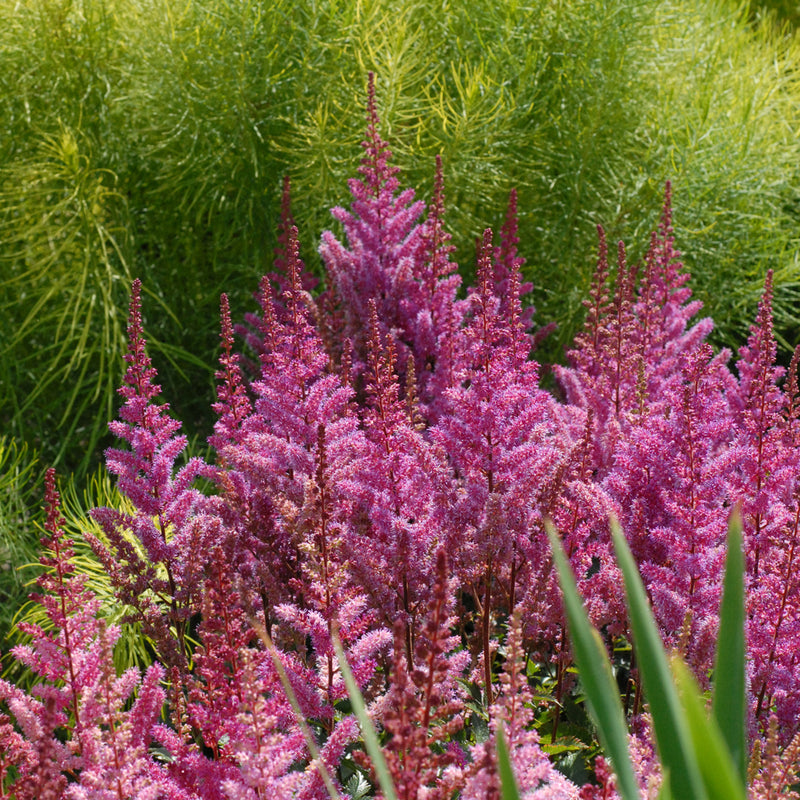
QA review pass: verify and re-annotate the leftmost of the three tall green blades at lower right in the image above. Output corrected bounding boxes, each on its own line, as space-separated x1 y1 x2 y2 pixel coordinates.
547 525 639 800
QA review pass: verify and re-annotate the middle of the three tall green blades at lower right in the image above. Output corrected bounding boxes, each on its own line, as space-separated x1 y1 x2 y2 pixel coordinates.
611 521 708 800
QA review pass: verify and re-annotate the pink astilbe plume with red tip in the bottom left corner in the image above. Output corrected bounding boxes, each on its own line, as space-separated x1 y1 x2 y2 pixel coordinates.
0 470 177 800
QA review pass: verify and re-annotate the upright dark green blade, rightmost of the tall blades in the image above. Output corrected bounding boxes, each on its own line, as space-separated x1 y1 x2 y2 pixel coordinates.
711 509 747 780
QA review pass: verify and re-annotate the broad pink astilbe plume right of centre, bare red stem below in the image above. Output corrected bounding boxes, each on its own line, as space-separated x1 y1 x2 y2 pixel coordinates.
431 230 564 702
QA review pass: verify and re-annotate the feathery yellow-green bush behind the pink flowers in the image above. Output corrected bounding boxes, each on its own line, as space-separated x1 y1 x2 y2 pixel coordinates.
0 0 800 476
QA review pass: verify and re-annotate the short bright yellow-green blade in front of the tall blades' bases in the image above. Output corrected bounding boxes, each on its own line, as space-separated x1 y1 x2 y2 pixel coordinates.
672 658 746 800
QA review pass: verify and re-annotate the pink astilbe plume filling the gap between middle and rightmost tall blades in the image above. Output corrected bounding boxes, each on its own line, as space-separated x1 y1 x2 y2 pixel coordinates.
603 344 731 684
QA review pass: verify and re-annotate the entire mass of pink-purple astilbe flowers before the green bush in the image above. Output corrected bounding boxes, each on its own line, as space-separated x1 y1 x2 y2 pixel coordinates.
0 73 800 800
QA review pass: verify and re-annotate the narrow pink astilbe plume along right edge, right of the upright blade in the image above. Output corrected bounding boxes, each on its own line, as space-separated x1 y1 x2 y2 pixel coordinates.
728 272 800 743
